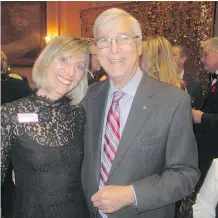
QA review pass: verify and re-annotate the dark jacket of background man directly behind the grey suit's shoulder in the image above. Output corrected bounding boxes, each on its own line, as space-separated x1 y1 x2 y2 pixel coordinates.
182 72 203 109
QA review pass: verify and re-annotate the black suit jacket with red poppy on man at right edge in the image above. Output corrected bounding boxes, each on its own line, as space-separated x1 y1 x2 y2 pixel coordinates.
194 81 218 175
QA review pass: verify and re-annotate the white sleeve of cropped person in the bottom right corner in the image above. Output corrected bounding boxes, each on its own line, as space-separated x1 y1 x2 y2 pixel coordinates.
193 158 218 218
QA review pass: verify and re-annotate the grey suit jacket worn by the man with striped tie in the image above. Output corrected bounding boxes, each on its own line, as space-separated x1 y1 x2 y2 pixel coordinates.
82 75 199 218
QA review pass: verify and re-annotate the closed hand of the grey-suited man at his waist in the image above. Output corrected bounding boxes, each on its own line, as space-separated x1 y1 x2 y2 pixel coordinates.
91 185 135 213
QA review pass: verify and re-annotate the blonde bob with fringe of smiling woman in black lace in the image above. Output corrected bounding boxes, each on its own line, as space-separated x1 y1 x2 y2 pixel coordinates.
32 35 91 105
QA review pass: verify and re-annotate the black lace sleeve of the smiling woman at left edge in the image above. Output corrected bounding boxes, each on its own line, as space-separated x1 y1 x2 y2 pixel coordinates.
1 105 14 183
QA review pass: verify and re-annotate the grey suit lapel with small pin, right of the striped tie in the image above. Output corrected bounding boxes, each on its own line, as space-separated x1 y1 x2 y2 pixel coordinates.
108 76 155 182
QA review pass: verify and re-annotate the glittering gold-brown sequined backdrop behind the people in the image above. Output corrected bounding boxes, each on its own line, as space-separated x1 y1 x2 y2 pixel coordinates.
80 1 215 89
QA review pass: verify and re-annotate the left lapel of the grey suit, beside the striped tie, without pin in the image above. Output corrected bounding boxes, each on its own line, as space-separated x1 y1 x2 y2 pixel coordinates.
92 80 109 184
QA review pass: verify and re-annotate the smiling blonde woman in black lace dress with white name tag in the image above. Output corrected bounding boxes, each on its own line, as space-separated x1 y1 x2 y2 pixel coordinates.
1 36 89 218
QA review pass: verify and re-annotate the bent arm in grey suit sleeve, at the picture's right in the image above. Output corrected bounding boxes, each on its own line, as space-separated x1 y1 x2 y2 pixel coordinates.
131 95 200 213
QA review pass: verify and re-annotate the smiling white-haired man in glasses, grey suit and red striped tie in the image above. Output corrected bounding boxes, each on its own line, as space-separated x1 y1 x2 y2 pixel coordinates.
82 8 199 218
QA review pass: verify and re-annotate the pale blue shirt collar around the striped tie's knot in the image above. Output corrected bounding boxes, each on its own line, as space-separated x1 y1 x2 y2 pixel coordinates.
109 68 143 97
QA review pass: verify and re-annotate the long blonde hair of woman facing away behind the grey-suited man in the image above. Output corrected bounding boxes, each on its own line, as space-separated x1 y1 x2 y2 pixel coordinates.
141 36 181 87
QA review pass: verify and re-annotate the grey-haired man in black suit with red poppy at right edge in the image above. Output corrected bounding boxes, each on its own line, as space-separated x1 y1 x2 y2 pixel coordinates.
192 37 218 177
